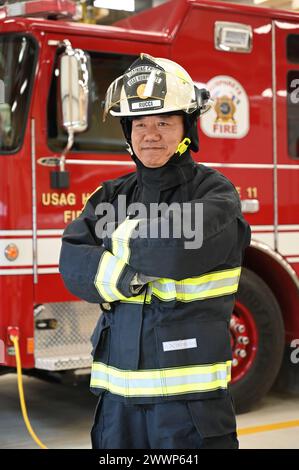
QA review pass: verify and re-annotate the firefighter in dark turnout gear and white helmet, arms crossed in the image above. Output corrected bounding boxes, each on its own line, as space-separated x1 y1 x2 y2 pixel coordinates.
60 54 250 449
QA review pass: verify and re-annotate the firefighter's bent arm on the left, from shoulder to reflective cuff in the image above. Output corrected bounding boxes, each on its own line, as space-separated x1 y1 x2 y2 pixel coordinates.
59 186 138 303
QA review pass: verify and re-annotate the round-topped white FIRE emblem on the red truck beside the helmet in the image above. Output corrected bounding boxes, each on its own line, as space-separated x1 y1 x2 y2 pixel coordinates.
200 75 249 139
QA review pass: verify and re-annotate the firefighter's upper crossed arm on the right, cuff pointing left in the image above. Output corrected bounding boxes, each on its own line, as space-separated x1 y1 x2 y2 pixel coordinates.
104 175 250 280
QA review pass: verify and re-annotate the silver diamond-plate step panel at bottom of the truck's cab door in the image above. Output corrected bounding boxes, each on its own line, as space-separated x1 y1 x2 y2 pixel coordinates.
35 302 101 371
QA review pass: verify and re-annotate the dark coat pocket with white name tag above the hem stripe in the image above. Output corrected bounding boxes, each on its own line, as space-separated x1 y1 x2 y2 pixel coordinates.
155 319 232 368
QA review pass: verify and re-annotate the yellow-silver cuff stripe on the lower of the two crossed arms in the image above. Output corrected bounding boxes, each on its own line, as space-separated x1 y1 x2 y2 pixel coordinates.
94 251 127 302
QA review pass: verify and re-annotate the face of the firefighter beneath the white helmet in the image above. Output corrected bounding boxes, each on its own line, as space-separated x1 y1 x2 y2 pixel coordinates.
131 114 184 168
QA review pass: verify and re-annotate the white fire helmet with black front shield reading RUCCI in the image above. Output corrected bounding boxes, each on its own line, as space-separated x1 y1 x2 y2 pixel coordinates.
103 54 211 120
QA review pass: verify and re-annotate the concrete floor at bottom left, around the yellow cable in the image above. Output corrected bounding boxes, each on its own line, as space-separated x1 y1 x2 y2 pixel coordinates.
0 374 97 449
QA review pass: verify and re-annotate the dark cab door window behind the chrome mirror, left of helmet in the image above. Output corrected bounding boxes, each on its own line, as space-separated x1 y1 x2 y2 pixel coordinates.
48 51 135 153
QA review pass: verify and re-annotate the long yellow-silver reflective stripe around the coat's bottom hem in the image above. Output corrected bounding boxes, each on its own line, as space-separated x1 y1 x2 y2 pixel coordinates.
90 361 231 397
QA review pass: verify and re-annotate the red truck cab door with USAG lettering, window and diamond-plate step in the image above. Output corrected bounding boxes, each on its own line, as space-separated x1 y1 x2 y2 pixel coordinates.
30 29 167 370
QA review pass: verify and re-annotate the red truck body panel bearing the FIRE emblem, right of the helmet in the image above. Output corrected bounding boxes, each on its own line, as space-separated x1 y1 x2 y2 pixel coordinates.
171 2 274 237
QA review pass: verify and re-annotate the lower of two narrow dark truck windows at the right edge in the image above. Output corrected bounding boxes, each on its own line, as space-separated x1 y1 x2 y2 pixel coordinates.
287 70 299 159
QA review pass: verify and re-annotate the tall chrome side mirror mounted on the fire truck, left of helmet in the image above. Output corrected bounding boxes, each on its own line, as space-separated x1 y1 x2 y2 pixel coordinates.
58 46 90 135
